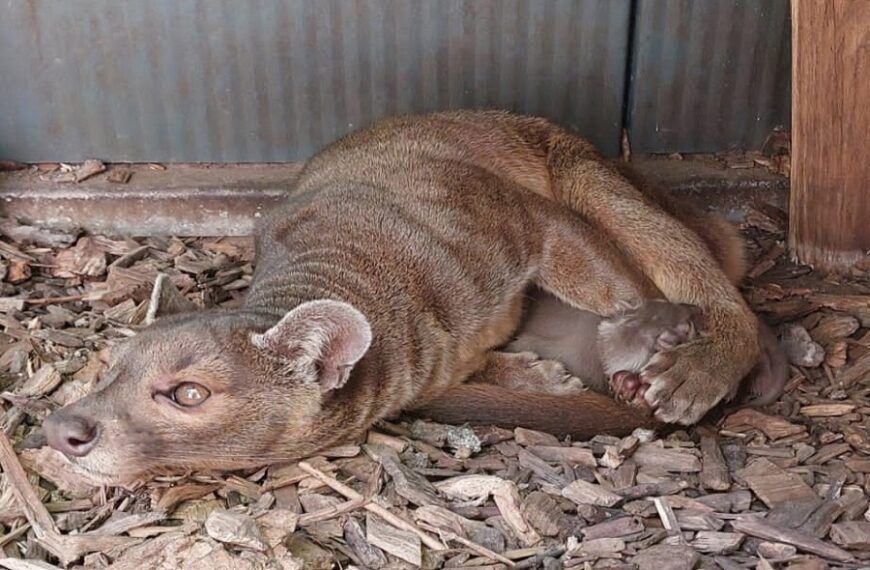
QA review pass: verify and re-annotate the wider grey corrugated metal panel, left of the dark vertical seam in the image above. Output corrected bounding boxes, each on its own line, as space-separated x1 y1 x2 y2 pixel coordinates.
0 0 630 162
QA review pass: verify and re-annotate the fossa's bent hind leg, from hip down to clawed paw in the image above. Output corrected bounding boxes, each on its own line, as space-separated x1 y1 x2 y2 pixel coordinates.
547 131 759 424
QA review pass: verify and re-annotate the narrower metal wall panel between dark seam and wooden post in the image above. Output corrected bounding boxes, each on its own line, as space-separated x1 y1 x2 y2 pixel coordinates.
628 0 791 152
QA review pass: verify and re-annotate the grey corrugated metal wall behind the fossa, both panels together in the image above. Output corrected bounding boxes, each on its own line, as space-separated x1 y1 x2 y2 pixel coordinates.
0 0 790 162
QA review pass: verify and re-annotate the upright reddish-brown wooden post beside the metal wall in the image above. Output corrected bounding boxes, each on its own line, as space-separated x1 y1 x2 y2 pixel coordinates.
789 0 870 271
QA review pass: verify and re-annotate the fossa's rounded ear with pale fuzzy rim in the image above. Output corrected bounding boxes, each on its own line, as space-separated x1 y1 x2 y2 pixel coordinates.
251 300 372 392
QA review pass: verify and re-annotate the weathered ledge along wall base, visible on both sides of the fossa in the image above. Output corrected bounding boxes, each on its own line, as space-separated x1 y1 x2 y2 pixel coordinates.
0 157 788 236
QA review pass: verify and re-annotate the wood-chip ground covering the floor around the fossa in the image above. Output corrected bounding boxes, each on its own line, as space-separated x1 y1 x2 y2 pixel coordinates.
0 193 870 570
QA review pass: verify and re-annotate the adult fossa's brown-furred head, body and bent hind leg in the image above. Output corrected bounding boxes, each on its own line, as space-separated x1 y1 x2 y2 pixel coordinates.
46 112 758 480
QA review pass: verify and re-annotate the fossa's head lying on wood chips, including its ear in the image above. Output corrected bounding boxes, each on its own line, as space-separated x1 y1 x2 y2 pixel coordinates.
44 300 372 483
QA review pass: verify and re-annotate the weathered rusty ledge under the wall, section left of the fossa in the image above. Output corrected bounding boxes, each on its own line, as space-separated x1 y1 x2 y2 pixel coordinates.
0 164 301 236
